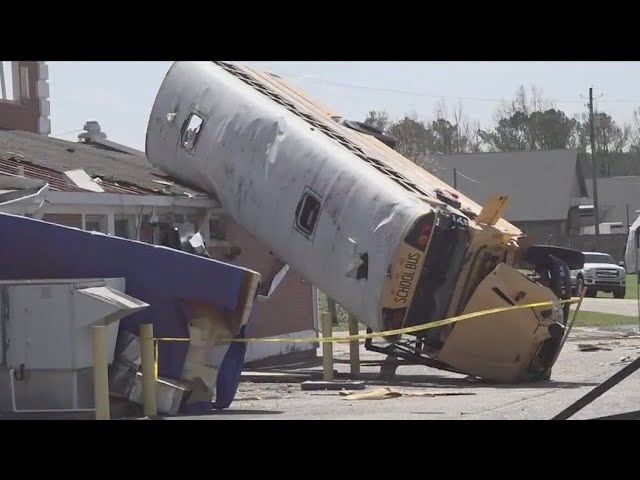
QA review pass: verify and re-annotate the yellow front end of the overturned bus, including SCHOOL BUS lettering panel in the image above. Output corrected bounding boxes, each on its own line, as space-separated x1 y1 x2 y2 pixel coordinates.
383 196 564 382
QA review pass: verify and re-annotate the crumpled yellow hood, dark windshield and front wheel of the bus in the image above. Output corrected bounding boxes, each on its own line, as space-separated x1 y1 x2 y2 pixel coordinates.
365 209 582 382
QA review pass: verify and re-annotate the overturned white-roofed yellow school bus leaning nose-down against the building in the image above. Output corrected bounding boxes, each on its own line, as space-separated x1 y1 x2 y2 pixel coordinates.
146 62 579 382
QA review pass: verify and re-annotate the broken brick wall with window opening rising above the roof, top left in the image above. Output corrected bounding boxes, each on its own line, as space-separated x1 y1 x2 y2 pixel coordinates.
0 61 51 135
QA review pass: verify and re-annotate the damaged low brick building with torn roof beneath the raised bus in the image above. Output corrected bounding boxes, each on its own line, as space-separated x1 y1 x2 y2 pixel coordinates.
0 119 318 362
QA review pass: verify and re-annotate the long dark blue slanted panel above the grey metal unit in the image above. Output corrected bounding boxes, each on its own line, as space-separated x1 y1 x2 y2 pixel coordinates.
0 213 258 408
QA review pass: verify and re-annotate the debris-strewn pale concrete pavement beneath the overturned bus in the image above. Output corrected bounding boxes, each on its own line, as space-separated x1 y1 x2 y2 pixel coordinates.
168 326 640 420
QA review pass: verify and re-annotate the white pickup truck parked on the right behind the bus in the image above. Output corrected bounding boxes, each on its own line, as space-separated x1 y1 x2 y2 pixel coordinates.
571 252 627 298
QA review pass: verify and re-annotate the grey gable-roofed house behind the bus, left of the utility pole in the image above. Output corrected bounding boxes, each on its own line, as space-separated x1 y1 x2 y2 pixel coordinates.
435 150 593 244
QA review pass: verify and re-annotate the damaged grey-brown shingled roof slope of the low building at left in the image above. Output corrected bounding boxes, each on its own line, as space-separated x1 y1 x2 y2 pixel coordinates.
0 129 208 198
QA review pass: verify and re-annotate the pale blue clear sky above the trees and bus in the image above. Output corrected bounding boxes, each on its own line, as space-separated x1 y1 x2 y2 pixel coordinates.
49 61 640 149
